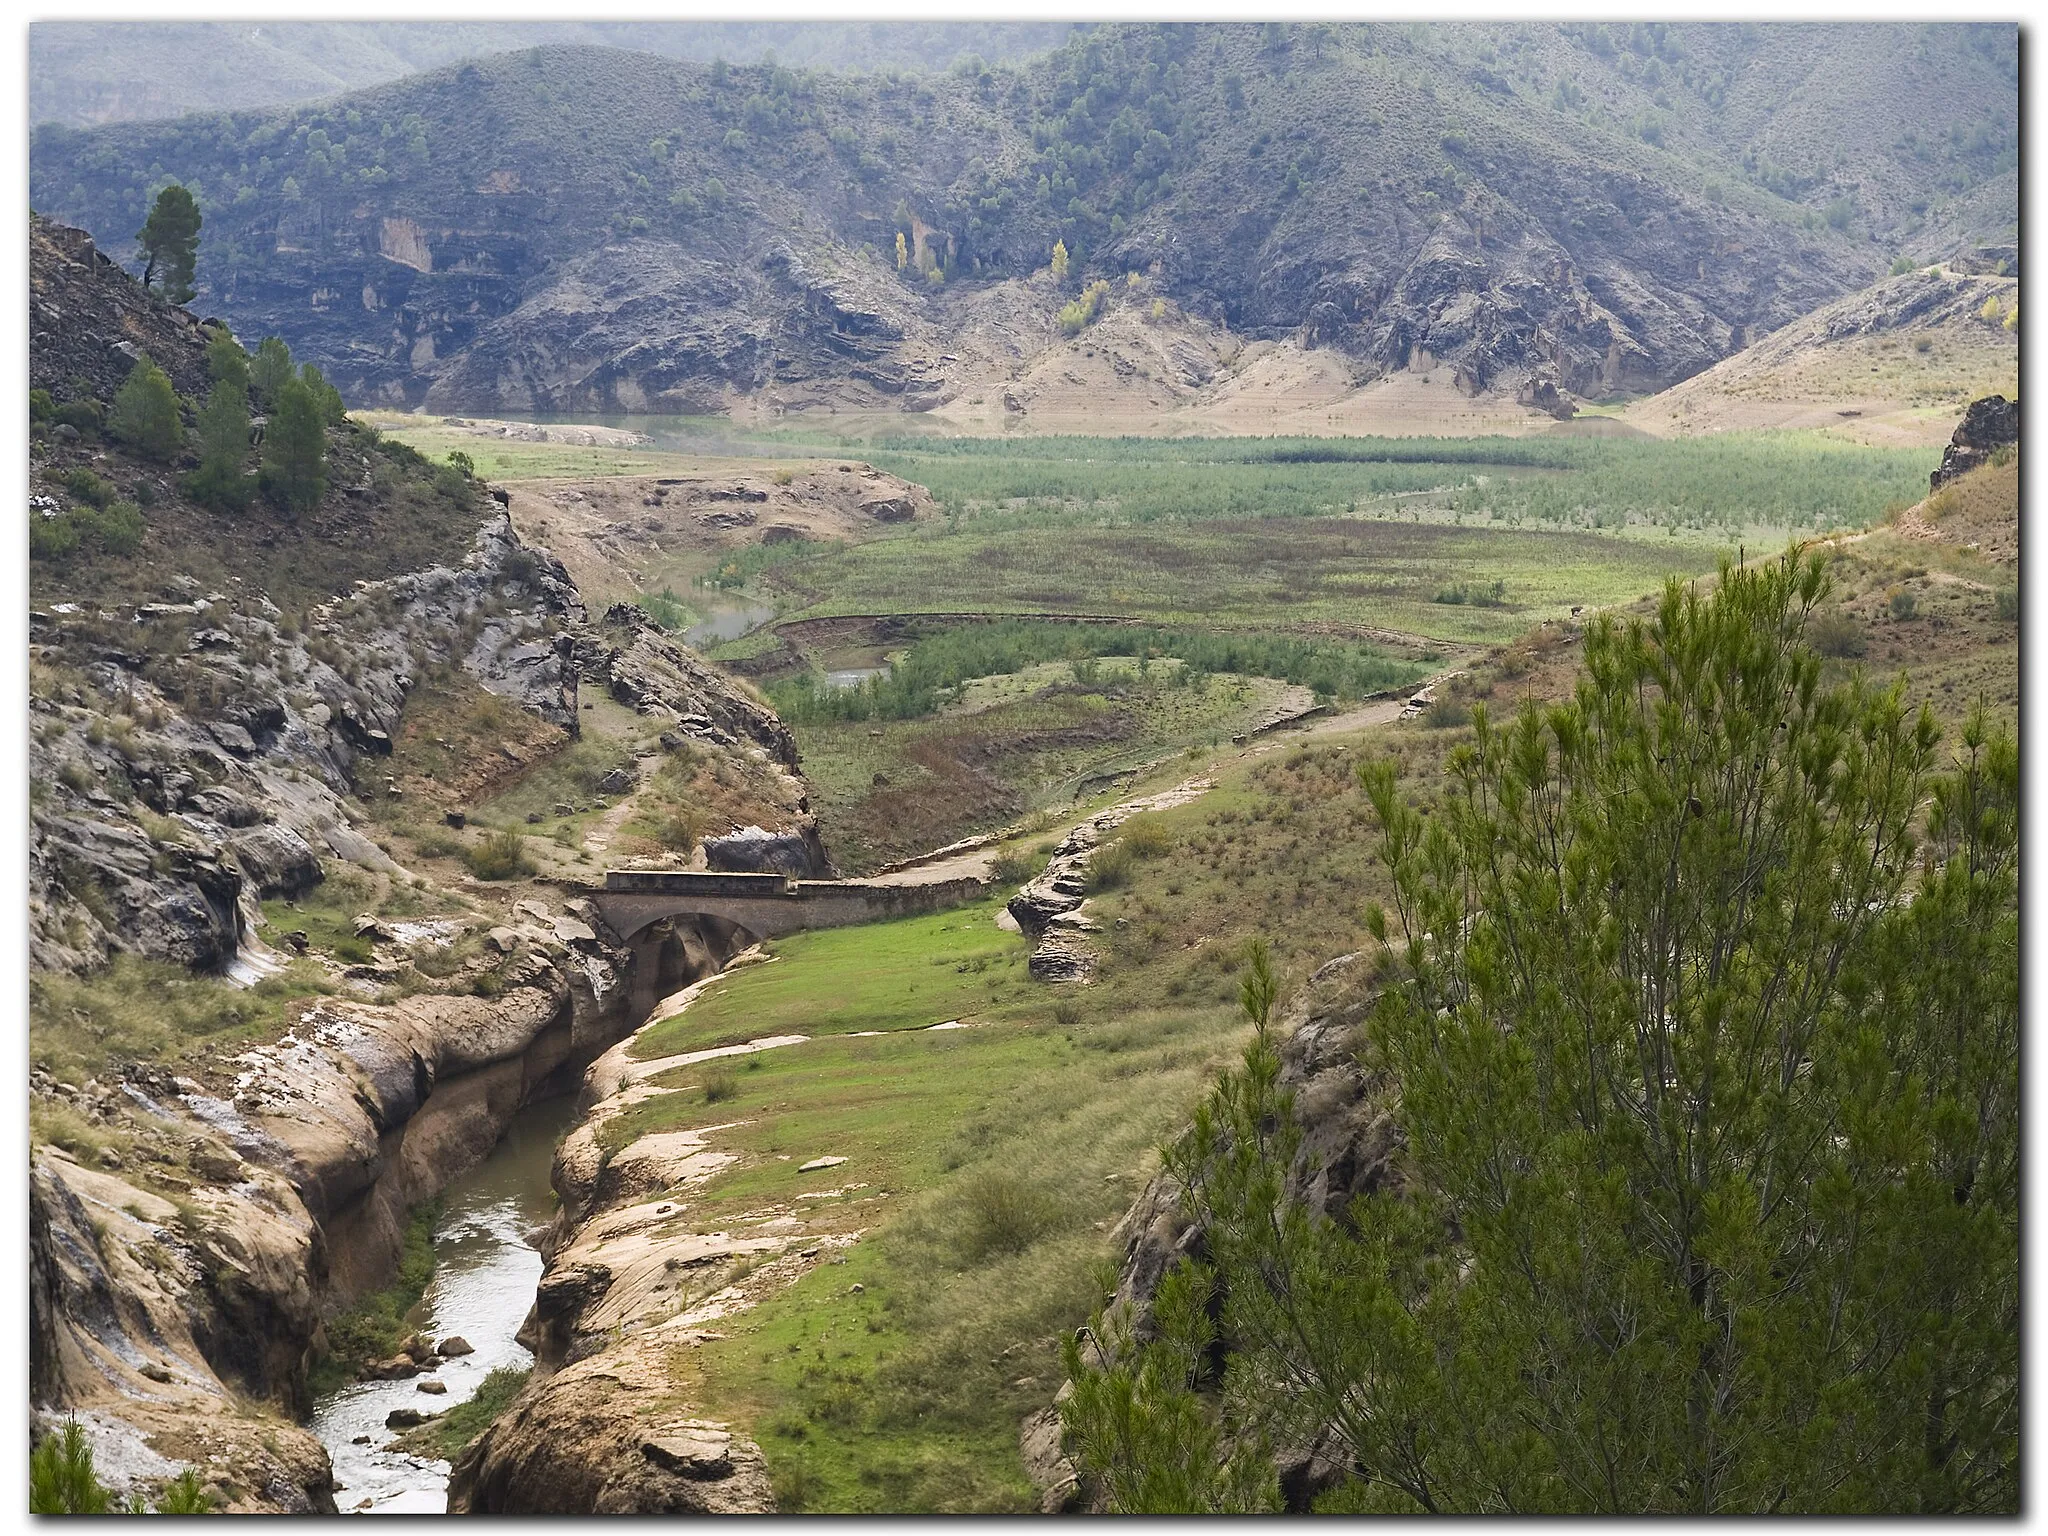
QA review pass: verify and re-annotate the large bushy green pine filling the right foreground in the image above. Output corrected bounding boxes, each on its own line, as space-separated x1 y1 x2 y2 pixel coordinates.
1067 557 2019 1513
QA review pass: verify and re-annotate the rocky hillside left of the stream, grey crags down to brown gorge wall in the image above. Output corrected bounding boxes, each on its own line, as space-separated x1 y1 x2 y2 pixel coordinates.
27 225 807 1511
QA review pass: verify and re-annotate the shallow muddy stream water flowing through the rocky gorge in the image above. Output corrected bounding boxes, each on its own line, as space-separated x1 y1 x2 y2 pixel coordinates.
311 1098 575 1516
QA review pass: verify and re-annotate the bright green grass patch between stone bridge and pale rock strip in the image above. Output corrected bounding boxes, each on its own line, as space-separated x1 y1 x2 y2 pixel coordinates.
633 901 1036 1061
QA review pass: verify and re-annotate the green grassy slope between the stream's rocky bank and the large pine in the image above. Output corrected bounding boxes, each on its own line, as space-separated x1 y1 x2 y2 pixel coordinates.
604 727 1456 1513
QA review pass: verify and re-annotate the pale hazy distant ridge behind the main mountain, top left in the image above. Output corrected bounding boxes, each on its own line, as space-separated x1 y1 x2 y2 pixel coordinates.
29 20 1073 127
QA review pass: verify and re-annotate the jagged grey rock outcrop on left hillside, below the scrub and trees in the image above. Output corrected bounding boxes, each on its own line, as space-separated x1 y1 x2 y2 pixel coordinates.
29 516 585 971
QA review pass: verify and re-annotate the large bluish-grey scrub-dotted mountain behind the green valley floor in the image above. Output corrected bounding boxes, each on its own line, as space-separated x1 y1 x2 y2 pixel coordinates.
31 23 2017 428
